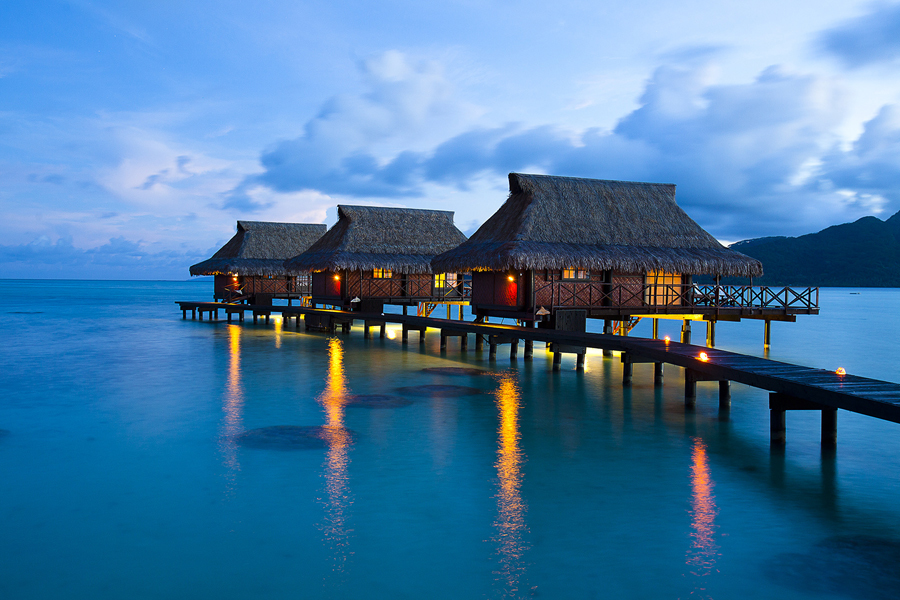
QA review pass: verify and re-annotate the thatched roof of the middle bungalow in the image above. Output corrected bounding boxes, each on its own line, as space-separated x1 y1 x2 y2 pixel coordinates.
284 205 466 274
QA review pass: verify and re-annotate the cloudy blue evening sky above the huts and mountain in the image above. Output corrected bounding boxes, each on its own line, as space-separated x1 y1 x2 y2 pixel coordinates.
0 0 900 279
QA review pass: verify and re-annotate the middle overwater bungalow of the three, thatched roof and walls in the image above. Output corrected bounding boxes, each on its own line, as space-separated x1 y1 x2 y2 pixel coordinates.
284 206 466 312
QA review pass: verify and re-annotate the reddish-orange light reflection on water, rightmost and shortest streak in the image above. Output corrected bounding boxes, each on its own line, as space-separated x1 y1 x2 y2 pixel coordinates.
687 437 719 598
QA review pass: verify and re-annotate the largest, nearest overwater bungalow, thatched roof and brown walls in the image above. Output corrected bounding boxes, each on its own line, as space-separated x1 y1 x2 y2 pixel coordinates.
432 173 762 328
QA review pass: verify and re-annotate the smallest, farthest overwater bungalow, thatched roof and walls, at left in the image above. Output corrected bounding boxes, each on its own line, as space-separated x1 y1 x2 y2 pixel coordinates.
191 221 327 304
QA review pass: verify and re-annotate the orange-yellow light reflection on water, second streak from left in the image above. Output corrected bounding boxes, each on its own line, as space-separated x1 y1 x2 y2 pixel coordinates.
319 338 352 574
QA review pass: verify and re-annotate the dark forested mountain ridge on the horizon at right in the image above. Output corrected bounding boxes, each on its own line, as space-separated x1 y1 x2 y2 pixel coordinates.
723 212 900 287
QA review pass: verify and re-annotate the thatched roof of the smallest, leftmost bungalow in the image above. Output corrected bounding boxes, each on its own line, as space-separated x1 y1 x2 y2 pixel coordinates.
191 221 327 276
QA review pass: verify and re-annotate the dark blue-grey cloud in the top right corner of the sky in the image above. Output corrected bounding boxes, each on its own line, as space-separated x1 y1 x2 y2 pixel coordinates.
817 3 900 68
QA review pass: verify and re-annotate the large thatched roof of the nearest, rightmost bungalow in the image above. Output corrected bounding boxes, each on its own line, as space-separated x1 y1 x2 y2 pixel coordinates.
431 173 762 277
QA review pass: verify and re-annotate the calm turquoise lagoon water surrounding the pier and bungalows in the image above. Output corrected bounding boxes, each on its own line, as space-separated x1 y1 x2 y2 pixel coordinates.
0 281 900 599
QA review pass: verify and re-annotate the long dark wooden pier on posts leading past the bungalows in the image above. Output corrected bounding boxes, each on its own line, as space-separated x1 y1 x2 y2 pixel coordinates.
176 302 900 446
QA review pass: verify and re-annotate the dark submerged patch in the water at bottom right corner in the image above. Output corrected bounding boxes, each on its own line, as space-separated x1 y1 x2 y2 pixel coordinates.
763 536 900 600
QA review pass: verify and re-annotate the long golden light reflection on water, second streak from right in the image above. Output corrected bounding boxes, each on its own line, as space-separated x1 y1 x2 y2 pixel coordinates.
494 375 528 598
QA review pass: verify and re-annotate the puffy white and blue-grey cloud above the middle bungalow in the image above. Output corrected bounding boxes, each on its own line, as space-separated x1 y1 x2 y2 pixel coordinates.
239 51 476 197
